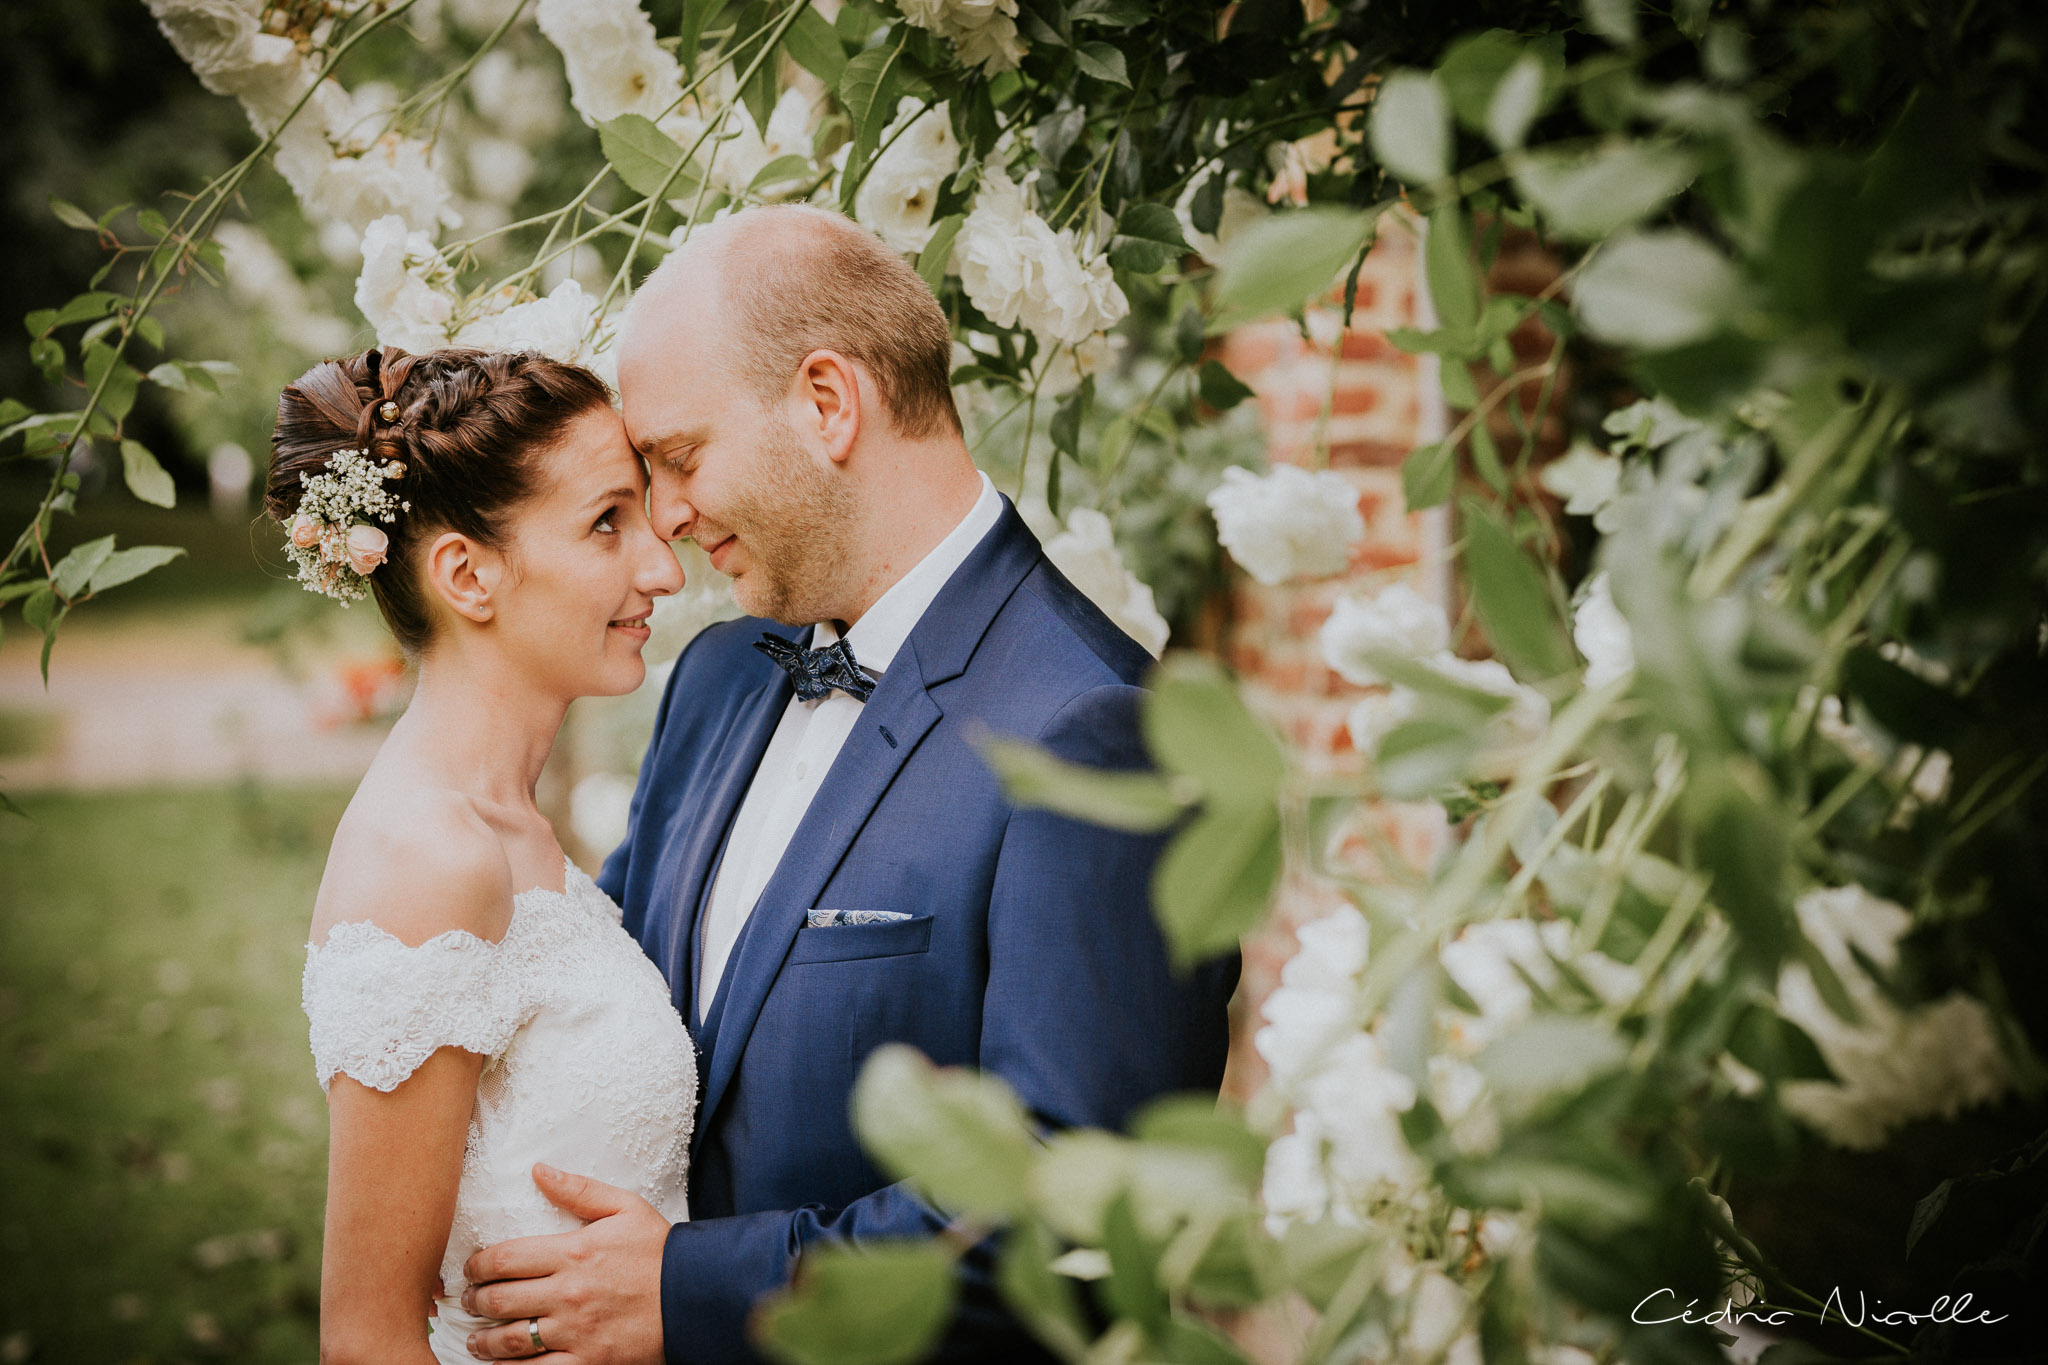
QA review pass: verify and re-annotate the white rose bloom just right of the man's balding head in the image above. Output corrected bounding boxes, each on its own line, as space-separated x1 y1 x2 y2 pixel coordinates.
952 166 1130 346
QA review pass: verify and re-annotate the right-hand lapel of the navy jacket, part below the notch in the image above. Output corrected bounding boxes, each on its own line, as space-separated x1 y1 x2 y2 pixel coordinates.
696 643 940 1134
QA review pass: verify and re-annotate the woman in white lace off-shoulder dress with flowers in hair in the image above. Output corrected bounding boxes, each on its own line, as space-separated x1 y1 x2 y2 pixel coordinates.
264 350 696 1365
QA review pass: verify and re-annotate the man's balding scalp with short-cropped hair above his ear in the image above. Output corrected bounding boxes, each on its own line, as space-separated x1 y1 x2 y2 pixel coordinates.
625 205 961 440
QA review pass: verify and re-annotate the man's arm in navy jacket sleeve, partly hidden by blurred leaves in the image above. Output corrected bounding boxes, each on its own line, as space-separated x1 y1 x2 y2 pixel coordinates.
662 686 1237 1365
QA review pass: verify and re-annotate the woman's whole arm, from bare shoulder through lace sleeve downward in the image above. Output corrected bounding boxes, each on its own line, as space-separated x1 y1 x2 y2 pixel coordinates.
305 794 516 1365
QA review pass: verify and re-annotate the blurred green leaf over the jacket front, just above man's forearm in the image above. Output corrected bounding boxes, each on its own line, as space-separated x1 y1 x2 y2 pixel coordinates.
854 1044 1036 1220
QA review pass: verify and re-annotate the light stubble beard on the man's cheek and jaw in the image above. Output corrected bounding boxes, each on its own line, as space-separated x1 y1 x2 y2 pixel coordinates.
721 424 856 626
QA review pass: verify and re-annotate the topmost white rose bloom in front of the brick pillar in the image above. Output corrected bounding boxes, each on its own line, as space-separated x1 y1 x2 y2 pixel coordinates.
1208 465 1366 587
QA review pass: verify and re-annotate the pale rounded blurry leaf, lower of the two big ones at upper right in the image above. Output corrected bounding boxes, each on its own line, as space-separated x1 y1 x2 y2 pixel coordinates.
1573 229 1737 350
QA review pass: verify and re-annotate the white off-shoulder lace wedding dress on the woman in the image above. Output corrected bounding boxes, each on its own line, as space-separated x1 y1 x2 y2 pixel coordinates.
303 864 696 1365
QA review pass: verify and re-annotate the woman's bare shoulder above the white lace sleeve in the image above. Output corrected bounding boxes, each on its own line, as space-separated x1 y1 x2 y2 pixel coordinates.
311 784 512 943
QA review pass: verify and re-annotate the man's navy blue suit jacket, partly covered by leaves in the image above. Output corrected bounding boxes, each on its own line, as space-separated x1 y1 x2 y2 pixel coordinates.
598 501 1237 1365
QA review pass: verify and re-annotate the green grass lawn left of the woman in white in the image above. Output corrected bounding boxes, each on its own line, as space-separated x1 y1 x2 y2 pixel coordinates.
0 788 346 1365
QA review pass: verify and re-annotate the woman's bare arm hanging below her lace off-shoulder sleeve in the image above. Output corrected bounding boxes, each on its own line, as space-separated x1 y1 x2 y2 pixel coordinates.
319 1048 483 1365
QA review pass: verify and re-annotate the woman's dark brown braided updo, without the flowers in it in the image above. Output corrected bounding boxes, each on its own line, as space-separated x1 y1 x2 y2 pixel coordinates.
264 346 610 659
